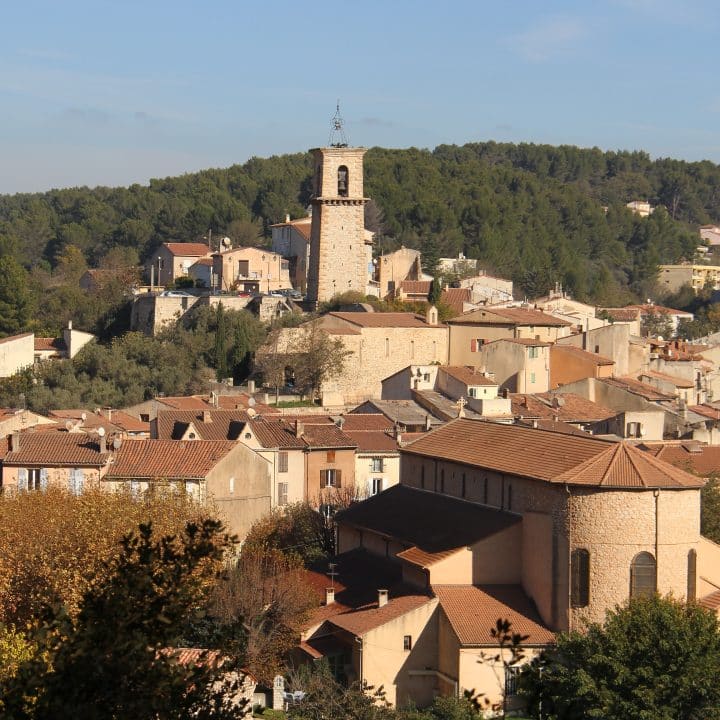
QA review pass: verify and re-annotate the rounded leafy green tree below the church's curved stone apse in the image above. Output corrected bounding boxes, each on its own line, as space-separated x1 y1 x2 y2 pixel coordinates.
520 596 720 720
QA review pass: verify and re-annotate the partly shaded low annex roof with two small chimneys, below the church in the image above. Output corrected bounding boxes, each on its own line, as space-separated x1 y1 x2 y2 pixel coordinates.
306 550 434 635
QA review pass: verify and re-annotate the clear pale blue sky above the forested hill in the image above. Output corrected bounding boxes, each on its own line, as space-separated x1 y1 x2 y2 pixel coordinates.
0 0 720 193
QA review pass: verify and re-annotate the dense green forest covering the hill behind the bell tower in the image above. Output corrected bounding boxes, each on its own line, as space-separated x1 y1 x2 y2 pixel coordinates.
0 142 720 334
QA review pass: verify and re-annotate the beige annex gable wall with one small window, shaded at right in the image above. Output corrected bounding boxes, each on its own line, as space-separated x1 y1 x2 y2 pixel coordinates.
362 598 438 707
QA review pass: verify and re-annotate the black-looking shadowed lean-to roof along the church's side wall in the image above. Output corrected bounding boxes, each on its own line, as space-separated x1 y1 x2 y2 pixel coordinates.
337 485 521 556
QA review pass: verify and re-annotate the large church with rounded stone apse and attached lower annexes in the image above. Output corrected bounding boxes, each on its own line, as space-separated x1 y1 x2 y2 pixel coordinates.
300 419 720 705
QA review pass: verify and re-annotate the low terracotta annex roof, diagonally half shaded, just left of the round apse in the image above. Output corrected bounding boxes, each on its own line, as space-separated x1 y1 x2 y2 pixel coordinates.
433 585 555 646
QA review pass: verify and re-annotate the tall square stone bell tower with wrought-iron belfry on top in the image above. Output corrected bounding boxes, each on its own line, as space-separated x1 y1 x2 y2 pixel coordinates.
307 107 372 304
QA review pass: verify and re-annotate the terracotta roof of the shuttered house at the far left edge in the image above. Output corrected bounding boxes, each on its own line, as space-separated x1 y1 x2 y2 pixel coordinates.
3 431 110 467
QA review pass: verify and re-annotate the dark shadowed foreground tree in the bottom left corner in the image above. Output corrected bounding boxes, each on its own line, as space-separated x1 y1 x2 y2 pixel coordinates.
0 520 245 720
